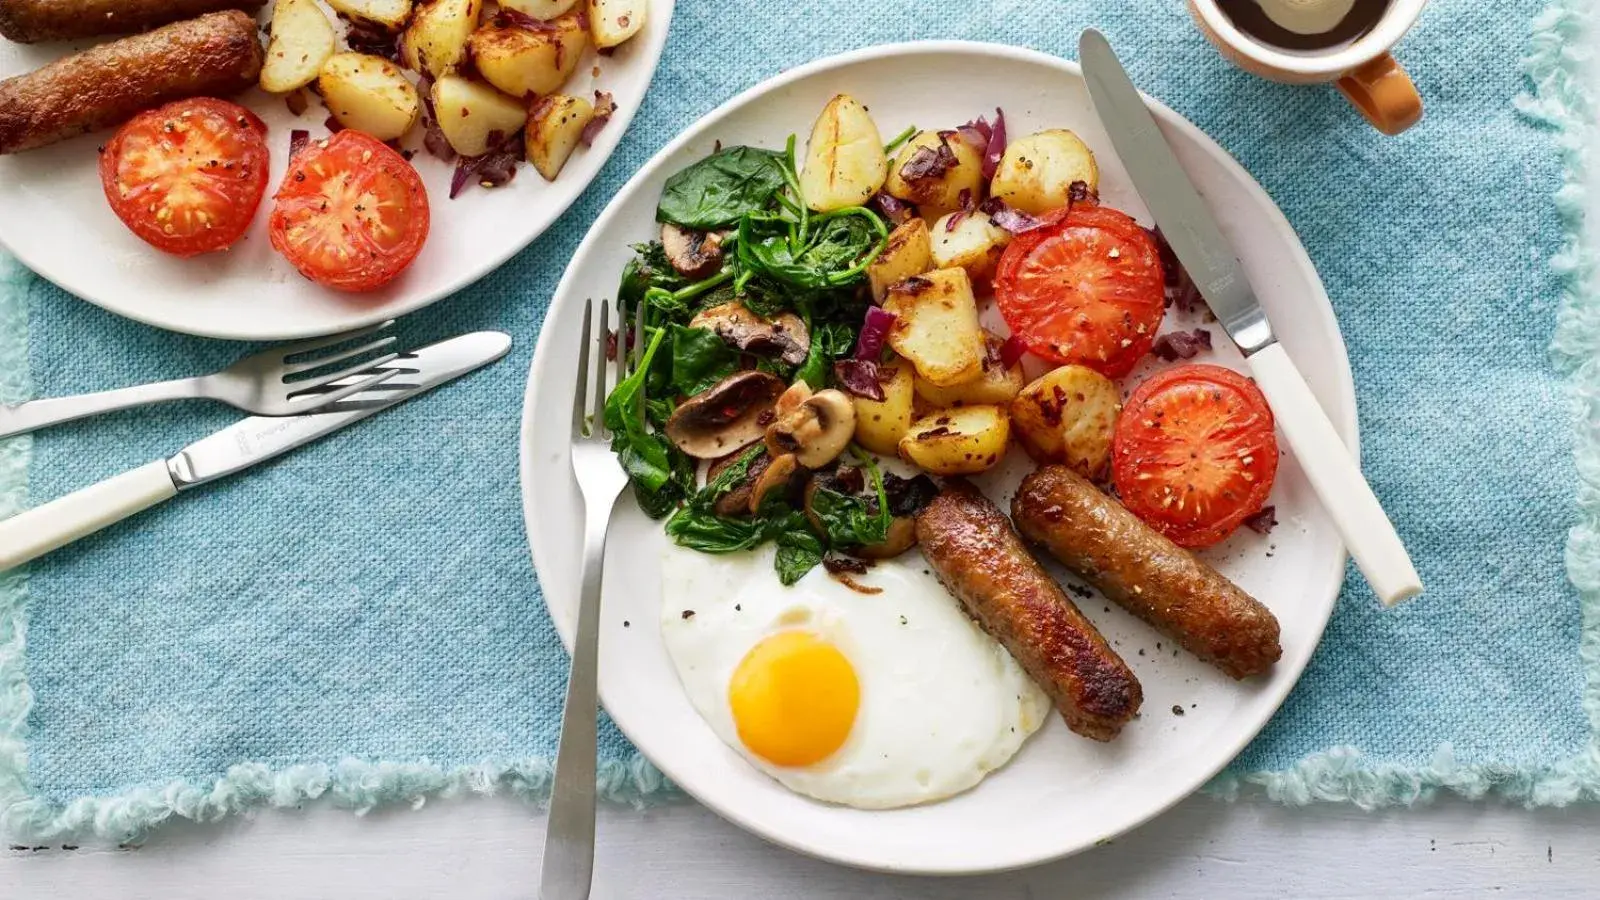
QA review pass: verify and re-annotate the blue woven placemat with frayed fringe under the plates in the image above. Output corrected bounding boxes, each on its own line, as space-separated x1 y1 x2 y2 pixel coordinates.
0 0 1600 841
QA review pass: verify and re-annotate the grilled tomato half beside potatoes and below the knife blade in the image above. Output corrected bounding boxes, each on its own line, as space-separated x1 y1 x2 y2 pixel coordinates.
995 202 1166 378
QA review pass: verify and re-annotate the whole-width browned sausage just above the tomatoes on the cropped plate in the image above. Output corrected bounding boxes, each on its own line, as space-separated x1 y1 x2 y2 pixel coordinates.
0 10 262 154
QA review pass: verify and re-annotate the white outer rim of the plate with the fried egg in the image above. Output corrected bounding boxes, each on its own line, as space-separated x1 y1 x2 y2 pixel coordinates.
517 40 1360 876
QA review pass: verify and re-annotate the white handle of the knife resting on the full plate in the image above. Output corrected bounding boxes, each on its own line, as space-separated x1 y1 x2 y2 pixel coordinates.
1250 344 1422 607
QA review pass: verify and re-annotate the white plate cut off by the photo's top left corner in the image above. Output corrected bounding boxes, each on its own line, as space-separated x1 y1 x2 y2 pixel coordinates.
0 0 675 341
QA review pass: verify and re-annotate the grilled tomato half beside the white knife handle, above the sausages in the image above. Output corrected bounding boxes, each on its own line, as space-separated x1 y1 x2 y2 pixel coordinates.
1110 364 1278 548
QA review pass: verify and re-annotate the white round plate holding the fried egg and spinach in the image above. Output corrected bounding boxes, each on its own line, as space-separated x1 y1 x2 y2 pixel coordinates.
522 42 1355 874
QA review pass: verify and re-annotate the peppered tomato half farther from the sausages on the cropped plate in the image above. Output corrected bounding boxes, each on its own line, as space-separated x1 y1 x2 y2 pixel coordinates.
267 130 429 291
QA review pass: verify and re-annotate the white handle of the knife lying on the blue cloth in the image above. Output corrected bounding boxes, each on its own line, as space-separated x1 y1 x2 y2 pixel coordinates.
0 460 178 572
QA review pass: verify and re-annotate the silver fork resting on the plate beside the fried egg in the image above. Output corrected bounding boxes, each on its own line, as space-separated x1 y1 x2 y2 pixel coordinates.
539 301 643 900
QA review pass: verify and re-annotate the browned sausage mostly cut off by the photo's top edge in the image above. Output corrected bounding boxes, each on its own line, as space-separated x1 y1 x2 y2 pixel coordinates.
0 0 266 43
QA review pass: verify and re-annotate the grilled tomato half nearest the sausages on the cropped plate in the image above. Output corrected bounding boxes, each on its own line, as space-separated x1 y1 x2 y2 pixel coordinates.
99 98 267 256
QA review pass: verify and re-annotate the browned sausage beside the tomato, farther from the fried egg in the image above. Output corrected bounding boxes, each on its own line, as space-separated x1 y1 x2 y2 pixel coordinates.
1011 466 1283 677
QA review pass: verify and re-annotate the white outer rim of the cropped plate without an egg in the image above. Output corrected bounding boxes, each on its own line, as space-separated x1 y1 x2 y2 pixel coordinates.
0 0 677 341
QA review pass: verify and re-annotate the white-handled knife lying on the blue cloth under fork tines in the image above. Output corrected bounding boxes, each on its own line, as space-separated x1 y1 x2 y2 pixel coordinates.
0 331 510 572
